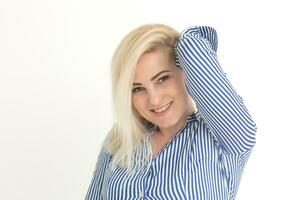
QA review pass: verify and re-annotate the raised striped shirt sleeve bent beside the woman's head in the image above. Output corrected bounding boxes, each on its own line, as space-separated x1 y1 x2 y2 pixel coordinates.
175 26 256 155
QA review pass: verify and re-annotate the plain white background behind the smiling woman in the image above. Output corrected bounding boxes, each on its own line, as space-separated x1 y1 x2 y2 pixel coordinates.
0 0 300 200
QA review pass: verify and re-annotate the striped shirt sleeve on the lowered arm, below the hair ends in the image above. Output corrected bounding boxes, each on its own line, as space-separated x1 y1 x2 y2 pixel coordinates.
85 147 111 200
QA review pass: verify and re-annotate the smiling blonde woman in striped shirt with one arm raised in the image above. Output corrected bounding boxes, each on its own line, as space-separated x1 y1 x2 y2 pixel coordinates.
86 24 256 200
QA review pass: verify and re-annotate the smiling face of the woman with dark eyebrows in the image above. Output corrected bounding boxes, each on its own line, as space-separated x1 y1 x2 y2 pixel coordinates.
132 48 192 133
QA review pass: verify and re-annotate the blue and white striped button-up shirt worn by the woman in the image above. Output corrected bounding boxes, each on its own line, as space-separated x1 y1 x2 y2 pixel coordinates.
86 26 256 200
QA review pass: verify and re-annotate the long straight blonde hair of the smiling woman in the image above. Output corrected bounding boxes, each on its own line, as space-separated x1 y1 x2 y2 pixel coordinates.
104 24 179 170
